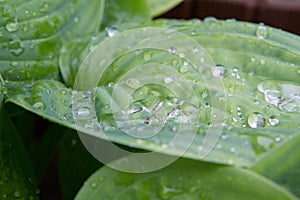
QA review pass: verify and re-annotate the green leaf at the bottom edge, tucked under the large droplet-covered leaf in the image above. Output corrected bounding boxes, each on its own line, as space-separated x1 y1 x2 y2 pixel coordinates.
75 159 296 200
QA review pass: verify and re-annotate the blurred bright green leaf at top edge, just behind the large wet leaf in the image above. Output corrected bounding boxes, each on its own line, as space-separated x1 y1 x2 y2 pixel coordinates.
101 0 151 29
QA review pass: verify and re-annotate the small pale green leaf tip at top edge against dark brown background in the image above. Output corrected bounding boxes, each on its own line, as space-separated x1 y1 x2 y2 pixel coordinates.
148 0 183 17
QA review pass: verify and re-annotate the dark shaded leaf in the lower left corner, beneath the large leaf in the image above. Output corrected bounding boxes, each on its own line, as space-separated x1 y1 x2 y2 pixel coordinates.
0 101 38 199
